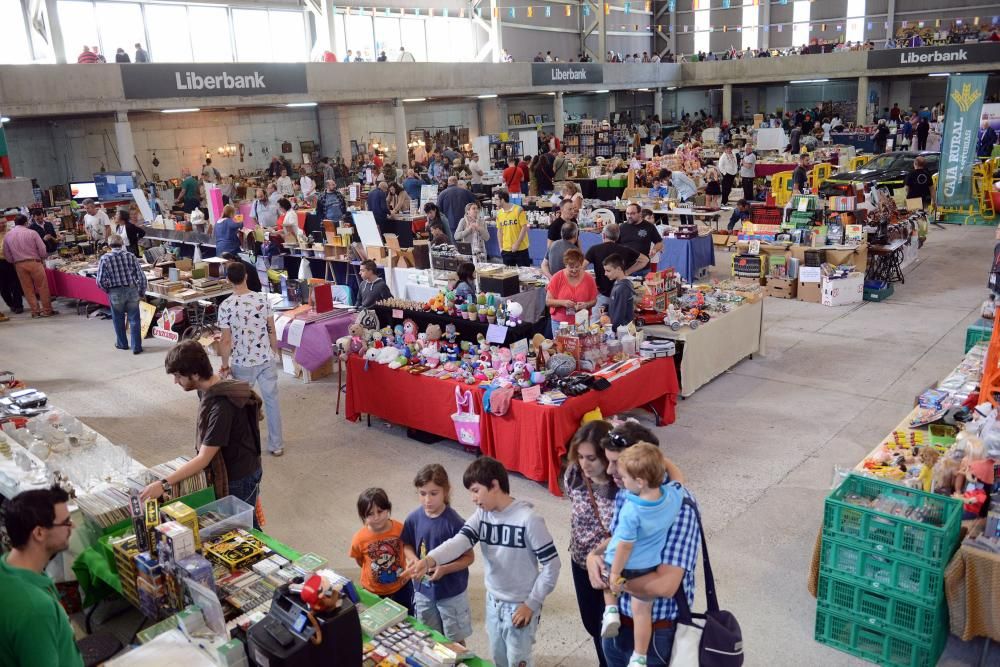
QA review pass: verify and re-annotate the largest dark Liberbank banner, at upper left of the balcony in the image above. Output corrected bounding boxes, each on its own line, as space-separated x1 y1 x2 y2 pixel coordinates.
121 63 309 100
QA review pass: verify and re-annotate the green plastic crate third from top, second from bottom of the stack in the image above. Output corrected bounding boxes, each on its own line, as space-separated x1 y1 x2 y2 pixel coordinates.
816 574 948 642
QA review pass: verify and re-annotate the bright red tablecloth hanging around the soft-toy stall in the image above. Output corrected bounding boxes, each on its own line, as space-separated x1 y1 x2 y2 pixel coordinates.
346 356 678 495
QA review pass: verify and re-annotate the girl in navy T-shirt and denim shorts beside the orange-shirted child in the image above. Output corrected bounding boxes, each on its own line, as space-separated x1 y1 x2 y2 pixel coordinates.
401 463 475 643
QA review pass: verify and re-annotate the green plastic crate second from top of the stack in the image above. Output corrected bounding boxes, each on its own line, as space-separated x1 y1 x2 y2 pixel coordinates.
819 535 944 606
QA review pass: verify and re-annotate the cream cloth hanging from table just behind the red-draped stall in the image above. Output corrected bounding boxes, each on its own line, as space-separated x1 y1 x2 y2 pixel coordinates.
642 299 767 398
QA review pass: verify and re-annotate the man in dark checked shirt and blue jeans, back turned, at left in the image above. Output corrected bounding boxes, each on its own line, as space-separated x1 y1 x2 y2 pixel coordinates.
97 234 146 354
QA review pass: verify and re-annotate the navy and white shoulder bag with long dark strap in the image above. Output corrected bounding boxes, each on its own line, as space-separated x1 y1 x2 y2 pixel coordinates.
670 498 743 667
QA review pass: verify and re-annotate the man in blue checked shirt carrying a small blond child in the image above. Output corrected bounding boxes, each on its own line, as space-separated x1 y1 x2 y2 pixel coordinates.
587 420 701 667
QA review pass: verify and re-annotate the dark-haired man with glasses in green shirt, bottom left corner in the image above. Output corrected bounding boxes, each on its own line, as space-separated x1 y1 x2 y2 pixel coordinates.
0 486 83 667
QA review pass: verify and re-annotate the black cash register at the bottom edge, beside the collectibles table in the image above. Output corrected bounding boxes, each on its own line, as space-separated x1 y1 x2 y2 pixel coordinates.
247 584 362 667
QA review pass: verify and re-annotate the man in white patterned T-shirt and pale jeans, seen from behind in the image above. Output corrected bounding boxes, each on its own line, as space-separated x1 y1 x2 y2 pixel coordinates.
218 262 285 456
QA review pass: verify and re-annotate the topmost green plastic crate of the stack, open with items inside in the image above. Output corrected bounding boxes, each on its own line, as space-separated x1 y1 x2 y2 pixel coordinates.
823 475 962 570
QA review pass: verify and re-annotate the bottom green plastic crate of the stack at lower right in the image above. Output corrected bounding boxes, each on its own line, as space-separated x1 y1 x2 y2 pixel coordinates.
815 607 948 667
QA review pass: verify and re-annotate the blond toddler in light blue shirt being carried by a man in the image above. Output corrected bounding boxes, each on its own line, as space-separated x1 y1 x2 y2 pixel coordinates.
601 442 684 667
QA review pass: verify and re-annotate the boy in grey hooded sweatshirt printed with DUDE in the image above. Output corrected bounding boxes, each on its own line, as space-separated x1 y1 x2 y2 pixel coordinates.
406 456 560 667
